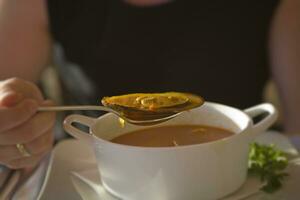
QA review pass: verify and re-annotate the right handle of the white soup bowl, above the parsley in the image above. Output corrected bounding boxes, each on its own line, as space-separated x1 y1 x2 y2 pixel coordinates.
244 103 278 135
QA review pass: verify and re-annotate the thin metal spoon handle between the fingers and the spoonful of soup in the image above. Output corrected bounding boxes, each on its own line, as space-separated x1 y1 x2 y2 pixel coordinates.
38 105 113 112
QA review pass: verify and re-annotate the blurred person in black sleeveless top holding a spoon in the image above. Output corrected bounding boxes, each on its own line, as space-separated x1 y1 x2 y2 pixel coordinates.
0 0 300 173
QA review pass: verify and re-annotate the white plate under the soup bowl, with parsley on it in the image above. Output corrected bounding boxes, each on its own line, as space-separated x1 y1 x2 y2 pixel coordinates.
40 132 300 200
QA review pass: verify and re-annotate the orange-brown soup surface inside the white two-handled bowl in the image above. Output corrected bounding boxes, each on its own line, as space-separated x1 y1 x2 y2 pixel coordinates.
111 125 234 147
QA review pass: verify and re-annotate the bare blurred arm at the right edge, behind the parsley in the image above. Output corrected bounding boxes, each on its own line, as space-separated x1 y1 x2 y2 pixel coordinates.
270 0 300 135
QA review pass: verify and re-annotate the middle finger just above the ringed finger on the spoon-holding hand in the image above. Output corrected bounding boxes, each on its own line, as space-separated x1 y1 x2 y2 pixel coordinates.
0 108 55 145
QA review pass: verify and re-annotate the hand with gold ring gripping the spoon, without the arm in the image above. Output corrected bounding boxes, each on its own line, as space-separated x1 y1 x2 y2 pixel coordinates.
0 78 55 169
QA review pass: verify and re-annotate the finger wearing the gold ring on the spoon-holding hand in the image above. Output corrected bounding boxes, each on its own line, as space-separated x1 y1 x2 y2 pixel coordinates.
0 129 54 164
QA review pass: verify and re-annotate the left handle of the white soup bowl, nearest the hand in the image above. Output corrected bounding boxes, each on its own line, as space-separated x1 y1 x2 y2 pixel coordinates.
64 114 96 141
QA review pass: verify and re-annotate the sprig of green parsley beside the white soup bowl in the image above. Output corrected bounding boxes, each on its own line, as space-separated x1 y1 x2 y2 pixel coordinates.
248 143 288 193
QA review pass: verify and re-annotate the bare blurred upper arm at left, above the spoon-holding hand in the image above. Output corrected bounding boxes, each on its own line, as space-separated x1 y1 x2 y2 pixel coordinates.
0 0 51 82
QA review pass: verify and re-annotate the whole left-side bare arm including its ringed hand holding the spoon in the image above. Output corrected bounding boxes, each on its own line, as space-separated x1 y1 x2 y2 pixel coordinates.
0 0 55 169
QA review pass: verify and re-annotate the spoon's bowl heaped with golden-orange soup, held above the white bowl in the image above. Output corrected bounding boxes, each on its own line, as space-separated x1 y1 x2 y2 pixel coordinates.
102 92 204 120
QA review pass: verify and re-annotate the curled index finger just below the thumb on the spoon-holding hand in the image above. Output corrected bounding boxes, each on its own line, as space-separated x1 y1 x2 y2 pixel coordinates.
0 99 38 133
